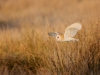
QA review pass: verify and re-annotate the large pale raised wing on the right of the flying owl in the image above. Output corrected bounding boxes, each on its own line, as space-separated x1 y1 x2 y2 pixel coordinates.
64 22 82 37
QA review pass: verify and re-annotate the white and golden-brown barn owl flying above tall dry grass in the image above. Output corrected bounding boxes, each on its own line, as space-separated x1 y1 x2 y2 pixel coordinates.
48 22 82 42
